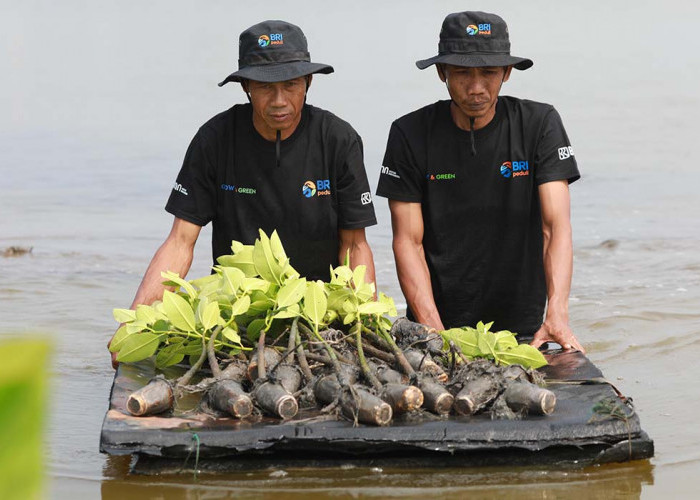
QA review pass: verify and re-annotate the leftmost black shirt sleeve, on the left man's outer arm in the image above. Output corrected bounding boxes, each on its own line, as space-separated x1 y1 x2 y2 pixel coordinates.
165 129 217 226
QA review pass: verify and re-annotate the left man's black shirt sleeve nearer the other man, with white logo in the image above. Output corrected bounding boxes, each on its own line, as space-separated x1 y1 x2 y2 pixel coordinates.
336 134 377 229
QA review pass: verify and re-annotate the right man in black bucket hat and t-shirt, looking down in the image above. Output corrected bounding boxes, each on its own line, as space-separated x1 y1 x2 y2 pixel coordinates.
377 12 583 350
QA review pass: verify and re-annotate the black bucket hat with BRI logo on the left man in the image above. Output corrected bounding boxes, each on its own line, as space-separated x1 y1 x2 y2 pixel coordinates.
219 21 333 87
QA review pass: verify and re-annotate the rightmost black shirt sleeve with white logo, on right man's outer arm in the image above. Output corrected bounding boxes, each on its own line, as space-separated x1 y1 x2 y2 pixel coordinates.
535 108 581 185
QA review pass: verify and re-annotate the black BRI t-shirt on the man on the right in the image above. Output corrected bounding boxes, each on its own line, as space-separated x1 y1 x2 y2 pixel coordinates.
377 96 579 334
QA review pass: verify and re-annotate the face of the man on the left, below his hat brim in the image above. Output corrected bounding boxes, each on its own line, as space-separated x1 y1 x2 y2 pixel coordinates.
244 77 310 140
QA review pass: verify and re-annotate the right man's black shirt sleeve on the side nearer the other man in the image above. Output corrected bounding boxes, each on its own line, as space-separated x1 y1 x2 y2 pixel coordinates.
377 122 425 203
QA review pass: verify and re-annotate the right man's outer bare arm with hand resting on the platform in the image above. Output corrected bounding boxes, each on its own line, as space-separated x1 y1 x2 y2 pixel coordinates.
532 180 585 352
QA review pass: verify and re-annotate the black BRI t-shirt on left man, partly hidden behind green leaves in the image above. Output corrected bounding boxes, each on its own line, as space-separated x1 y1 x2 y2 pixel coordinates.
165 104 376 280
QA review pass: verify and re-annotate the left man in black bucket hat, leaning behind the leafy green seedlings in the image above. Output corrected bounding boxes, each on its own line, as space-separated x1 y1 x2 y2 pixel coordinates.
112 21 376 365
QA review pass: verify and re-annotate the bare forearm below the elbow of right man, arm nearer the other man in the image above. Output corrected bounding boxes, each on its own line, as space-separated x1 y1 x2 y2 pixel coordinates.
394 240 444 330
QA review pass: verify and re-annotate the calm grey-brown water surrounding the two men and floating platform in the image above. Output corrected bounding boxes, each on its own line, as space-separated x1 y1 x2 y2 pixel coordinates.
0 0 700 499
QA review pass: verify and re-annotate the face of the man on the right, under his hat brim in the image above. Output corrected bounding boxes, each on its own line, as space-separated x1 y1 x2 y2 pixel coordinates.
438 64 512 128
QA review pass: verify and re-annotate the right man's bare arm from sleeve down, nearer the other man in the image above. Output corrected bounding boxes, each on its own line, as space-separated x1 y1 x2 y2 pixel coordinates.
389 200 445 330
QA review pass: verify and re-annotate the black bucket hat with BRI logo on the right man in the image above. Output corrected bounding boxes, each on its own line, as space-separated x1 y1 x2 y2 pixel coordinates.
416 12 533 69
